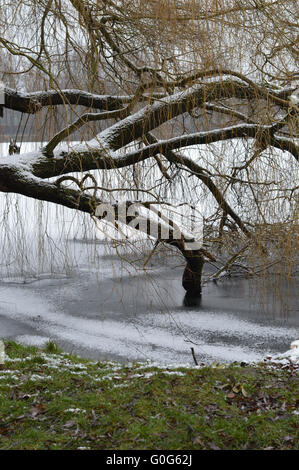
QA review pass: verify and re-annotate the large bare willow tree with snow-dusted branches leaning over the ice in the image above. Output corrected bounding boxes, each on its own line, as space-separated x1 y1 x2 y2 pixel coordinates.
0 0 299 292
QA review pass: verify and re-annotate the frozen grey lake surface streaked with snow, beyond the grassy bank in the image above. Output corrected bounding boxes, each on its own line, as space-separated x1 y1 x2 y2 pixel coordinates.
0 240 299 364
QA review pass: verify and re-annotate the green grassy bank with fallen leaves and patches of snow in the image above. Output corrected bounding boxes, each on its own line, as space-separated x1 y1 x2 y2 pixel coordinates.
0 342 299 450
